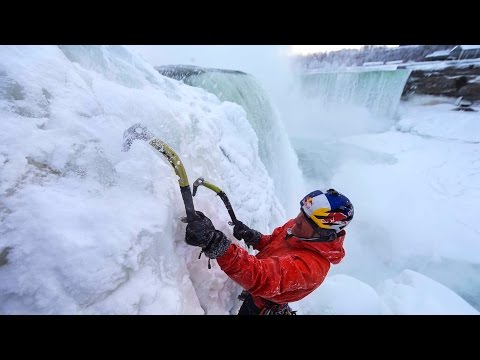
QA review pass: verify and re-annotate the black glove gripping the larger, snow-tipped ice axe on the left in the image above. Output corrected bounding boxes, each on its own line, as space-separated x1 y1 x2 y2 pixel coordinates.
185 211 231 259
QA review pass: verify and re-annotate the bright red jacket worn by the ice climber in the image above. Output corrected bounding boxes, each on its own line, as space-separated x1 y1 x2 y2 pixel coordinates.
217 219 345 309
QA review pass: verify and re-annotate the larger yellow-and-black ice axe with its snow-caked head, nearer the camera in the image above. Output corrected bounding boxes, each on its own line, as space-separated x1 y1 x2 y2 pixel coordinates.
122 124 198 222
